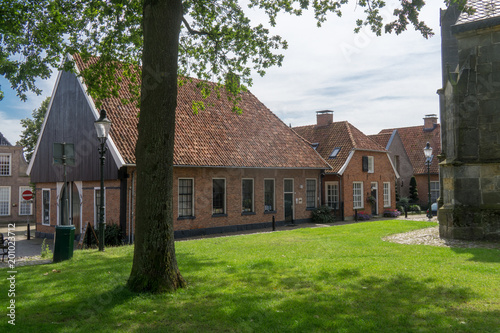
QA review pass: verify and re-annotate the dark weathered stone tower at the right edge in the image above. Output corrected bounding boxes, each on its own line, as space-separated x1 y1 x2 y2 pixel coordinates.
438 0 500 240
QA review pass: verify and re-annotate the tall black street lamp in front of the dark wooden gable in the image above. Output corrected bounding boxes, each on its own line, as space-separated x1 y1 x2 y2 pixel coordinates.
94 110 111 251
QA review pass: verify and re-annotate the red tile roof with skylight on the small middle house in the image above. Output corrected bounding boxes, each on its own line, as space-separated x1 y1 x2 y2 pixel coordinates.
293 121 386 173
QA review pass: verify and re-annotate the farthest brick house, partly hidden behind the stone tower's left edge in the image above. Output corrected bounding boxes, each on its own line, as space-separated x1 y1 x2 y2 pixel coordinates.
376 114 441 209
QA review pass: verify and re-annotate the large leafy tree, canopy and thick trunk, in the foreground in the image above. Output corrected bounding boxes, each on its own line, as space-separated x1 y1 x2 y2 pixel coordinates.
0 0 464 292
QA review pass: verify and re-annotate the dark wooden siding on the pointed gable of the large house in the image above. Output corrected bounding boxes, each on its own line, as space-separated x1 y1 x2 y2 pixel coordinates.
31 72 118 183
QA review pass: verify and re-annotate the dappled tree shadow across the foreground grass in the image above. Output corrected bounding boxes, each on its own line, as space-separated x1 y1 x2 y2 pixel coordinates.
10 245 500 333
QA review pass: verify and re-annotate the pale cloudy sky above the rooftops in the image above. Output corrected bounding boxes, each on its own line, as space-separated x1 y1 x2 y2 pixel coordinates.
0 0 444 144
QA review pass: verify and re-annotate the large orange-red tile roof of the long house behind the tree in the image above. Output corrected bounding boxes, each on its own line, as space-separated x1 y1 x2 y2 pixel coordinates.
74 56 329 169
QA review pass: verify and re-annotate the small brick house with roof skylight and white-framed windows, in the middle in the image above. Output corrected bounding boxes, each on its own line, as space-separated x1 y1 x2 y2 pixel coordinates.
293 111 398 219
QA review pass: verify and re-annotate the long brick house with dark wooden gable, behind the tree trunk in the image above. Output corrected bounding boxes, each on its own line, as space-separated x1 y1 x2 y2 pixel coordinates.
29 56 329 241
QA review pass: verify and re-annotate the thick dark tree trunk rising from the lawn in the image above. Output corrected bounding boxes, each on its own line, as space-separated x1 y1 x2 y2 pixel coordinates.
128 0 186 293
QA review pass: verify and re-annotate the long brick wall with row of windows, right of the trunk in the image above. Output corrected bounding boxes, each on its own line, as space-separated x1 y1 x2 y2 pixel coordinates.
174 167 319 230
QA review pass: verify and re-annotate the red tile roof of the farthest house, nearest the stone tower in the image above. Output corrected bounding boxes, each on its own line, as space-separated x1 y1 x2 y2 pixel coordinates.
378 124 441 174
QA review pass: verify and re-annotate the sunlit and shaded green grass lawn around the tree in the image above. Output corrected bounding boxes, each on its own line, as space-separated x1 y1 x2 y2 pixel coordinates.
0 220 500 333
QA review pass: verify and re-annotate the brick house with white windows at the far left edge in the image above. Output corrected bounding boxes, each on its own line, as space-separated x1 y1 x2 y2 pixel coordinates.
0 133 33 222
